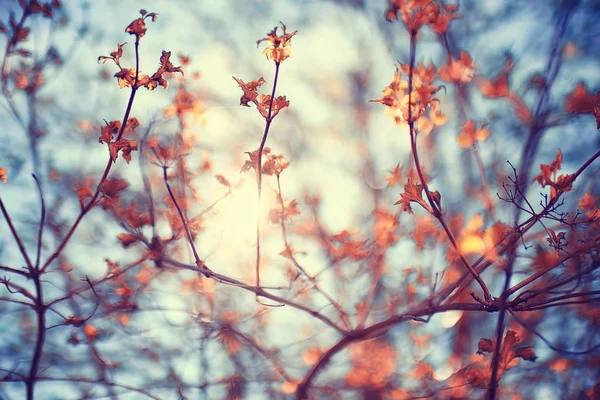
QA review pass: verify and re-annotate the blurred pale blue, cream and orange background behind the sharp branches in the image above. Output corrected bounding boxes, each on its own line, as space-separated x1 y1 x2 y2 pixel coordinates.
0 0 600 399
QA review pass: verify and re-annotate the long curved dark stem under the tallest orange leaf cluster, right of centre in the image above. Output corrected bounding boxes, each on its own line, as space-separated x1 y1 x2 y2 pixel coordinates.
408 32 492 303
